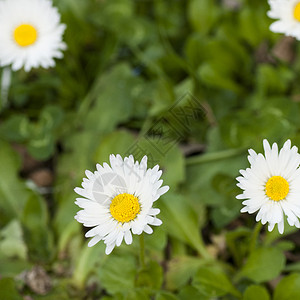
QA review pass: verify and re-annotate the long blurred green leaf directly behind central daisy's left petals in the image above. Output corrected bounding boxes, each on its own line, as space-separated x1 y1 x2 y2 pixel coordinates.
54 131 98 251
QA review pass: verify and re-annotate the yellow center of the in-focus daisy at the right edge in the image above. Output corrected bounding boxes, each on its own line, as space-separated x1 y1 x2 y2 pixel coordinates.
266 176 290 201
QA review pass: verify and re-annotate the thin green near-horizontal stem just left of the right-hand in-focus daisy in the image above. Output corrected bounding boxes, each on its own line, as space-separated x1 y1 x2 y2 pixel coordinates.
186 148 245 165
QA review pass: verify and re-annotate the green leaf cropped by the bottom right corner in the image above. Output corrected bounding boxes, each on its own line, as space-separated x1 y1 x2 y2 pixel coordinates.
274 274 300 300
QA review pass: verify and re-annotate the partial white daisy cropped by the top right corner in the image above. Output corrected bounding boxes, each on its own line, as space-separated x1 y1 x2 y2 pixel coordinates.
267 0 300 40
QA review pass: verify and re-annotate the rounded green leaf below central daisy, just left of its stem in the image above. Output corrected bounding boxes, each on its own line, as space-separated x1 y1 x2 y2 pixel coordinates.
98 255 137 294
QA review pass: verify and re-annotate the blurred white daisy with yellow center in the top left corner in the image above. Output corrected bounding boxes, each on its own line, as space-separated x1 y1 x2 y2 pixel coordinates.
0 0 66 72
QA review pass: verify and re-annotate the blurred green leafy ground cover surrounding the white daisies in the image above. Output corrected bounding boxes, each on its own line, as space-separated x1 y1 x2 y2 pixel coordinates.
0 0 300 300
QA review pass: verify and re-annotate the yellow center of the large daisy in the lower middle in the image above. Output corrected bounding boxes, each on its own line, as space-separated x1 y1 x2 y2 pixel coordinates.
109 193 141 223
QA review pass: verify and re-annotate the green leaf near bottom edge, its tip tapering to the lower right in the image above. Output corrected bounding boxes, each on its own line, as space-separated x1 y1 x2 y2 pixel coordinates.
192 266 240 298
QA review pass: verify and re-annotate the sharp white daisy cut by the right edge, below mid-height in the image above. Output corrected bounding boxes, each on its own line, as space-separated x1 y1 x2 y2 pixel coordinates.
236 140 300 234
